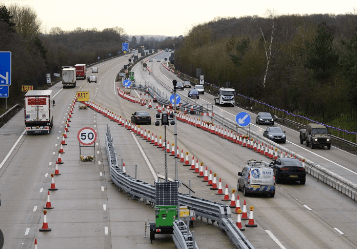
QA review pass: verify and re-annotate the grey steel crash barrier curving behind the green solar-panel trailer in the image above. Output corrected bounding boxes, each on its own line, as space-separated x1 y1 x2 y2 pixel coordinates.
105 127 254 249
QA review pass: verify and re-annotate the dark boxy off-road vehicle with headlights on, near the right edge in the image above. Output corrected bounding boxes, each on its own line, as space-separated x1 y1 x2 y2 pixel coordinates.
300 123 331 149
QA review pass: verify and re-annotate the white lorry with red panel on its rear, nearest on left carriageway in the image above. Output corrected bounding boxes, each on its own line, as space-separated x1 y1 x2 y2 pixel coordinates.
24 90 54 134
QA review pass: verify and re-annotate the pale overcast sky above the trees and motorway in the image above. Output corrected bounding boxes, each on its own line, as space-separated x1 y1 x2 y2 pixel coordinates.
0 0 357 36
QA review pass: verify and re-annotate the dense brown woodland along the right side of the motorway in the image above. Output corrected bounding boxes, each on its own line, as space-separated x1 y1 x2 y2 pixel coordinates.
175 13 357 130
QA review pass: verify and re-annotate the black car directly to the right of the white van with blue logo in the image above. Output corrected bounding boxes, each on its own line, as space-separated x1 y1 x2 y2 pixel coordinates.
269 158 306 184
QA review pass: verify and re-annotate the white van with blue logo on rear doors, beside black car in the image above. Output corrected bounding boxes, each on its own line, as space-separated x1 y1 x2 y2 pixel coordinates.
237 159 275 197
